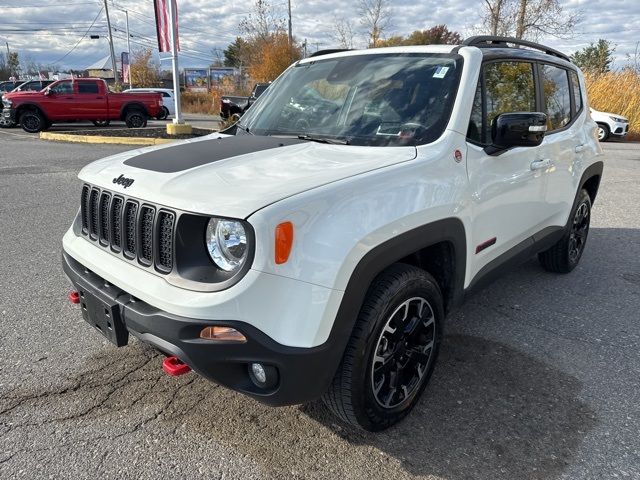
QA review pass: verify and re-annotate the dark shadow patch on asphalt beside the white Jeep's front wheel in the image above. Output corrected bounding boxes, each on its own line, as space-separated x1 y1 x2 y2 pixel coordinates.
304 335 596 480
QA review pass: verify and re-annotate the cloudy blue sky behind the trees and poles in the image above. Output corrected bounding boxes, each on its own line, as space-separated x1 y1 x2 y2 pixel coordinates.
0 0 640 69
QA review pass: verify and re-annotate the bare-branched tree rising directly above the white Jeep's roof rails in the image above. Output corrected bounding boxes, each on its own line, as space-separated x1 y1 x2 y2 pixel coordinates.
483 0 580 40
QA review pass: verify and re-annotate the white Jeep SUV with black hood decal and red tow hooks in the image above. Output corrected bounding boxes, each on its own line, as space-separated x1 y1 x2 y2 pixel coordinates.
63 37 603 430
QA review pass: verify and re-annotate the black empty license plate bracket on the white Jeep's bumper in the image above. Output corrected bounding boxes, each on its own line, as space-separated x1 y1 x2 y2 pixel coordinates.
78 290 129 347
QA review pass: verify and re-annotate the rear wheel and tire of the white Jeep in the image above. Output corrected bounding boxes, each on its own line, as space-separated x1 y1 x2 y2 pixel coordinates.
538 189 591 273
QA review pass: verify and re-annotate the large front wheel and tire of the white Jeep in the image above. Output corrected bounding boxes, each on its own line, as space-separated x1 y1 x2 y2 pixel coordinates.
322 264 444 431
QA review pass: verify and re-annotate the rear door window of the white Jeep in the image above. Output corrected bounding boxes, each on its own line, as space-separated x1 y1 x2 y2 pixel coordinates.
542 65 571 131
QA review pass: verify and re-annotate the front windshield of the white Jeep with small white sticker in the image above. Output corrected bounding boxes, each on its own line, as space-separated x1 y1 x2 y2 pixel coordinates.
239 53 462 146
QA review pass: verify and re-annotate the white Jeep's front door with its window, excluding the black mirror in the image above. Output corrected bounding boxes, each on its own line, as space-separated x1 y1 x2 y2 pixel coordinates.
467 61 554 278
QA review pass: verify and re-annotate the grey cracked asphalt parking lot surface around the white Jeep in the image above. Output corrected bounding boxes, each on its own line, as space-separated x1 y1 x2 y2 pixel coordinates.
0 130 640 480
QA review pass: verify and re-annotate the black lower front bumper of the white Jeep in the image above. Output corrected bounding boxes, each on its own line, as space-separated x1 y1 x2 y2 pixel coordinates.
62 252 344 406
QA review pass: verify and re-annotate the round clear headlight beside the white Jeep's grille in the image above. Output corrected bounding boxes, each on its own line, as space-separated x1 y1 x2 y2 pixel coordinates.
206 218 249 272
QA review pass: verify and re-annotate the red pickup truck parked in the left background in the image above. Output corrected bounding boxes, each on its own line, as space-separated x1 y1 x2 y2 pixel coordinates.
2 78 162 133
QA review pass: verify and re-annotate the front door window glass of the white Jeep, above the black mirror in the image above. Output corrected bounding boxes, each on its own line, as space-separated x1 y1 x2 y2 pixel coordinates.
467 61 536 144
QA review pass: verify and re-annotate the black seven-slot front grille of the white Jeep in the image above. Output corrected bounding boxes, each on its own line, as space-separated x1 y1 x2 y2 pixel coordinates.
80 185 176 273
